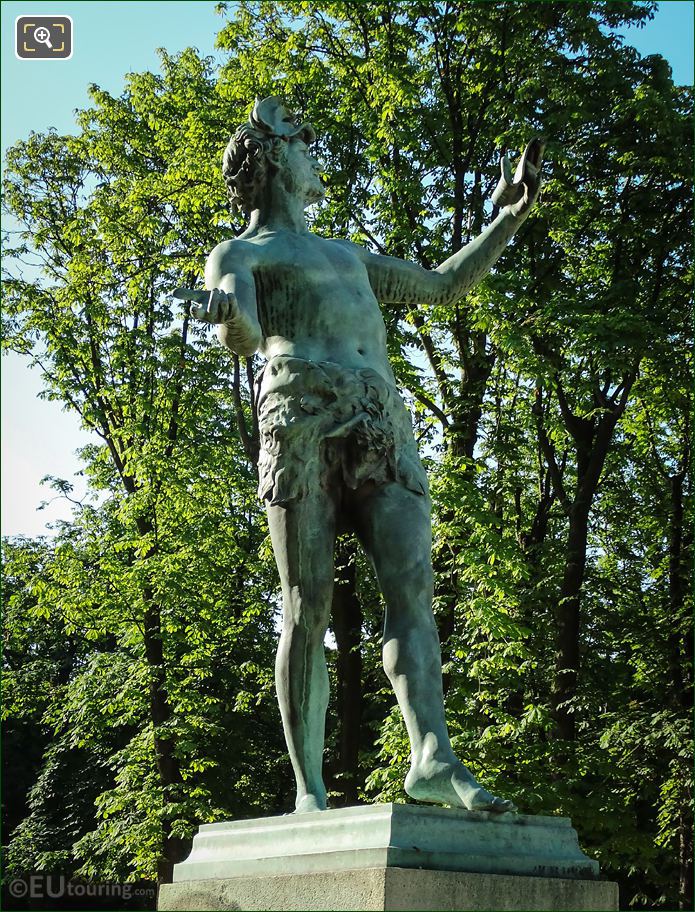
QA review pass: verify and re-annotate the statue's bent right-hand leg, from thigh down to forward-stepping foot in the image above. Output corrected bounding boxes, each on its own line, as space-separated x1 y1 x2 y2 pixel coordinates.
356 484 514 812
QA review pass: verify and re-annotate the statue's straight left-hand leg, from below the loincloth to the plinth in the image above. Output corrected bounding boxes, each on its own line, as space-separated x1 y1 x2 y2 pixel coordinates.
268 493 336 813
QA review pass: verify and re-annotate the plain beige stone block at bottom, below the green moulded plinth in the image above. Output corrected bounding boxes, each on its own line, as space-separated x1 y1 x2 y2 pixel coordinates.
158 867 618 912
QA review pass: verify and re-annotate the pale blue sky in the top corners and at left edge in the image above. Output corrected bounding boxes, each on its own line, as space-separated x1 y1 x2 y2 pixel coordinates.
0 0 695 535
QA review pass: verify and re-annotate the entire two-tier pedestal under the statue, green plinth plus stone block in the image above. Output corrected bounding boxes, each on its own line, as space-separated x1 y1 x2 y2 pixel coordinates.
158 804 618 912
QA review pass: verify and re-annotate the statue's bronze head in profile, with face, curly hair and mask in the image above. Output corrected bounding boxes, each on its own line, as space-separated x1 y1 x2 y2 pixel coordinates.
222 96 323 215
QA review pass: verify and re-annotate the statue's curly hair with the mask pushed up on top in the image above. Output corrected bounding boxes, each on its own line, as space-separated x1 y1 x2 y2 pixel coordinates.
222 96 316 215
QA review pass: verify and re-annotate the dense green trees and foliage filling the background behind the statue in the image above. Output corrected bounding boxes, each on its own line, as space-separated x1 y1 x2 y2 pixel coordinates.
3 0 692 908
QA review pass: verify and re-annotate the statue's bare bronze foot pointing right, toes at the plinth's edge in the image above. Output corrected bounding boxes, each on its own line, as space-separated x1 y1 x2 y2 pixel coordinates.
405 760 516 814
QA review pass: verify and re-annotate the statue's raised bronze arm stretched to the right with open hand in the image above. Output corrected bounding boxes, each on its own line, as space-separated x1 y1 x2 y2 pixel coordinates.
363 139 544 304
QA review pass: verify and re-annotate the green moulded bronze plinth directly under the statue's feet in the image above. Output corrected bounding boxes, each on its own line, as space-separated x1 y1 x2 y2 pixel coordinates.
167 804 599 883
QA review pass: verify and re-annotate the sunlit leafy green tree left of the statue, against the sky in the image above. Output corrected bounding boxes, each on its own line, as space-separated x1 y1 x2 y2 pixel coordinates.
4 52 286 879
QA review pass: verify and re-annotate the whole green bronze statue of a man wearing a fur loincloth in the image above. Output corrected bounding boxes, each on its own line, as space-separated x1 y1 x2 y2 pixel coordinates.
175 97 543 813
